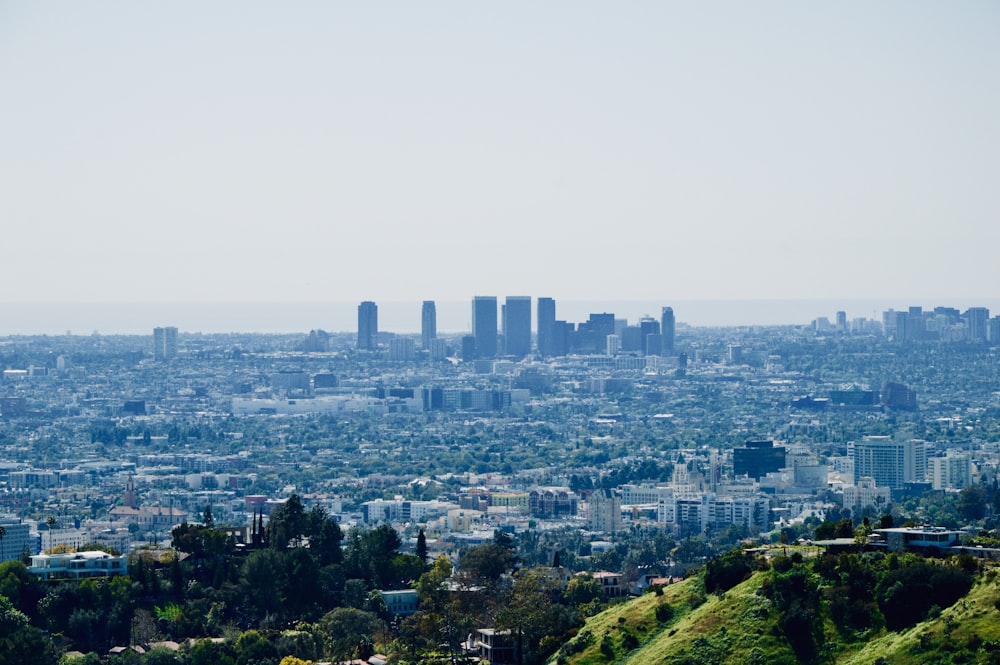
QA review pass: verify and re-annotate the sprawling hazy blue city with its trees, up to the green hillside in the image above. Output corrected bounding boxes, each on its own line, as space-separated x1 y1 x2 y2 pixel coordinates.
0 296 1000 663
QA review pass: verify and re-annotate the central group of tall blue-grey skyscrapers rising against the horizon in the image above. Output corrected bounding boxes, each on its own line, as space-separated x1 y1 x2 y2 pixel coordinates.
358 296 675 360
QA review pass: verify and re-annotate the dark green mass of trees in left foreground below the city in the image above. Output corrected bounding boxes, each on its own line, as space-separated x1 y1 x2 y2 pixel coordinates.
0 495 632 665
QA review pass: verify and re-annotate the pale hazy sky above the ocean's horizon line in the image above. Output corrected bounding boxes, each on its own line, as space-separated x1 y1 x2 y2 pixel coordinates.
0 0 1000 305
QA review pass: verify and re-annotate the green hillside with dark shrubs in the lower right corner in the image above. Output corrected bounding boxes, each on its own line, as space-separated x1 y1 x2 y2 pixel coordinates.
549 555 1000 665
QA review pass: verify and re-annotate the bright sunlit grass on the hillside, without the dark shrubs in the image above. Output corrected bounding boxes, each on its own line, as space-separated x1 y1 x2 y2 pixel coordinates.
550 571 1000 665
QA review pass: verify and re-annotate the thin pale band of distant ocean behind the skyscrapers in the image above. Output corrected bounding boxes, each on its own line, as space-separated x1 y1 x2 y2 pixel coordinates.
0 296 1000 336
